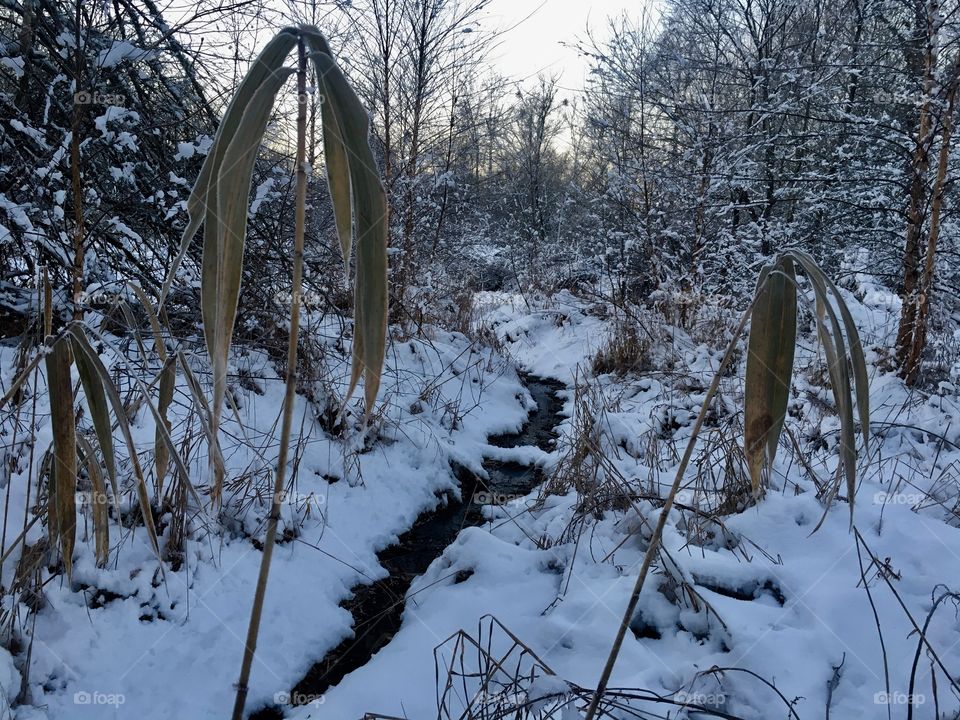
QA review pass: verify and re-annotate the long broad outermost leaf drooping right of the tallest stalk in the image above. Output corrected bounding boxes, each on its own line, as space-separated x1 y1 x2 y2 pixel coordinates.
311 52 388 413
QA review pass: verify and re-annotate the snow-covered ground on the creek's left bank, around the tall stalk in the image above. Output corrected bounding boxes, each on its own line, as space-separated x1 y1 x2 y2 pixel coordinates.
0 316 531 719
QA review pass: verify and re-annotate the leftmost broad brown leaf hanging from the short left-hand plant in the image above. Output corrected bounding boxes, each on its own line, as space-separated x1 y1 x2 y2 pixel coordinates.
46 340 77 577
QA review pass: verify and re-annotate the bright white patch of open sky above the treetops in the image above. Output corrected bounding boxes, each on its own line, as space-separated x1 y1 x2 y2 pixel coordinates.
482 0 655 90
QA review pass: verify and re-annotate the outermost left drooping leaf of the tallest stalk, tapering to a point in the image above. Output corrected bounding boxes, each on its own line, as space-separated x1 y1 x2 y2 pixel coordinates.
157 28 297 312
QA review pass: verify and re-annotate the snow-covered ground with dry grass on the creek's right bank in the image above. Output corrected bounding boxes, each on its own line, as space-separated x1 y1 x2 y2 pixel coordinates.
295 278 960 718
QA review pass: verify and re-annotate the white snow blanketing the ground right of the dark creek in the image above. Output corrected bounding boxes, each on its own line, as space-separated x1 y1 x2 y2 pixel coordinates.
286 288 960 719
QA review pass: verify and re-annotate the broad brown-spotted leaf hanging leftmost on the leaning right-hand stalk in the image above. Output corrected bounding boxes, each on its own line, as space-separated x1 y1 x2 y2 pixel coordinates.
744 260 797 492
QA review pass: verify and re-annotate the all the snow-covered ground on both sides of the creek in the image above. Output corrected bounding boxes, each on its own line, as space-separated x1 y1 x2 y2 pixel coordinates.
0 277 960 720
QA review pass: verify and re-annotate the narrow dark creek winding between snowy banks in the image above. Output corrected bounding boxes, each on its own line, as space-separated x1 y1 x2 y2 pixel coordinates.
250 375 564 720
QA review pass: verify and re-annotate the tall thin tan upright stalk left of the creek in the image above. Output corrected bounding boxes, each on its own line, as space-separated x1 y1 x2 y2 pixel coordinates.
233 37 307 720
